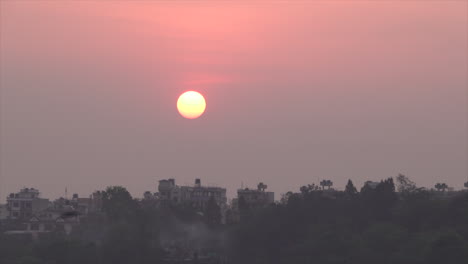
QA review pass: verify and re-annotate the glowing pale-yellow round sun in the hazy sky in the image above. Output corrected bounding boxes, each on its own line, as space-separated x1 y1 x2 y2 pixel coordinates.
177 91 206 119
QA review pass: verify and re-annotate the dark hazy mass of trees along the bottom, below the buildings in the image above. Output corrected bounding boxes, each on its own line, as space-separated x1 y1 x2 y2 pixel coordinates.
0 175 468 264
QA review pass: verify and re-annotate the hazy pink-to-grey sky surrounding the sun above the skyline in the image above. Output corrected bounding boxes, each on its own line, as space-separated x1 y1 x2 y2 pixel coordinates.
0 0 468 201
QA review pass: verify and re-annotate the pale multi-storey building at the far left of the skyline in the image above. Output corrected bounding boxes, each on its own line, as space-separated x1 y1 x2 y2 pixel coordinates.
7 188 50 219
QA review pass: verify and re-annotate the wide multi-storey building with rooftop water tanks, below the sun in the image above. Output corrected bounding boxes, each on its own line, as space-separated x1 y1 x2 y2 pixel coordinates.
156 179 227 211
